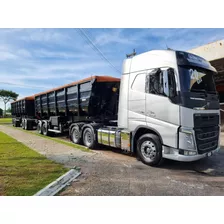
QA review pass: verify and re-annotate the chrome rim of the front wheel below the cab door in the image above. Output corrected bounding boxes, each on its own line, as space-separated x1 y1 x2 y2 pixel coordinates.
141 141 157 161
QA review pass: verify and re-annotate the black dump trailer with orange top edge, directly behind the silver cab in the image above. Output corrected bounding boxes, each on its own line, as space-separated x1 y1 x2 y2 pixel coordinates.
35 76 120 136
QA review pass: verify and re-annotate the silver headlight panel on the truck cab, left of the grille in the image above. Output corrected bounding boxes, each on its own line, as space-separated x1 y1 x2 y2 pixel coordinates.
179 128 196 150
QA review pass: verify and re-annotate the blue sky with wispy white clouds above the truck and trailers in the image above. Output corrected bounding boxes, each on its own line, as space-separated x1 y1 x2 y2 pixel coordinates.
0 28 224 108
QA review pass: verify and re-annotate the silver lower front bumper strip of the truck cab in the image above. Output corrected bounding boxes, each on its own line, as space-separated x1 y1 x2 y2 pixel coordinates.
163 146 220 162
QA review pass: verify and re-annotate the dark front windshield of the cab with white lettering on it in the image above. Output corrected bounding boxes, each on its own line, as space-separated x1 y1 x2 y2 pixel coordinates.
179 66 216 94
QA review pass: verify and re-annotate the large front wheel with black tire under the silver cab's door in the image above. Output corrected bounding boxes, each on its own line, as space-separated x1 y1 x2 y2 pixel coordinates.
137 134 163 166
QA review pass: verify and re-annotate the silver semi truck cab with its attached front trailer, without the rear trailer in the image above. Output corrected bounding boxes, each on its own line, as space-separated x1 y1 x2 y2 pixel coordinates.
10 50 220 166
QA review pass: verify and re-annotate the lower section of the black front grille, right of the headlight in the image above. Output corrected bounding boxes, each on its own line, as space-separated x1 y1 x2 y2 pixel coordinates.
195 126 219 154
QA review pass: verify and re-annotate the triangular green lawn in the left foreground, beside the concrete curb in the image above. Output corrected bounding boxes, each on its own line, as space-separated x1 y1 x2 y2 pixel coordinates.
0 132 68 196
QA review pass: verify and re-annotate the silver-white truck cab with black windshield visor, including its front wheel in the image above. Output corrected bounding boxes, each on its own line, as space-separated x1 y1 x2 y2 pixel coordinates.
117 50 220 165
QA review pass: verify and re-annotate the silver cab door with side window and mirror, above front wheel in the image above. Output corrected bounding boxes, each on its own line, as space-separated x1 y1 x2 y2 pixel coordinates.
146 68 180 148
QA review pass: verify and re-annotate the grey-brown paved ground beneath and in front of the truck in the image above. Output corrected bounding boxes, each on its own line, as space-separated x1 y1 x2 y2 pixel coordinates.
0 126 224 195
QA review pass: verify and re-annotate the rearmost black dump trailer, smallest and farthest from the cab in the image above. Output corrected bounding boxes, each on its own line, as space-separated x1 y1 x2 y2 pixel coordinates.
11 96 37 130
